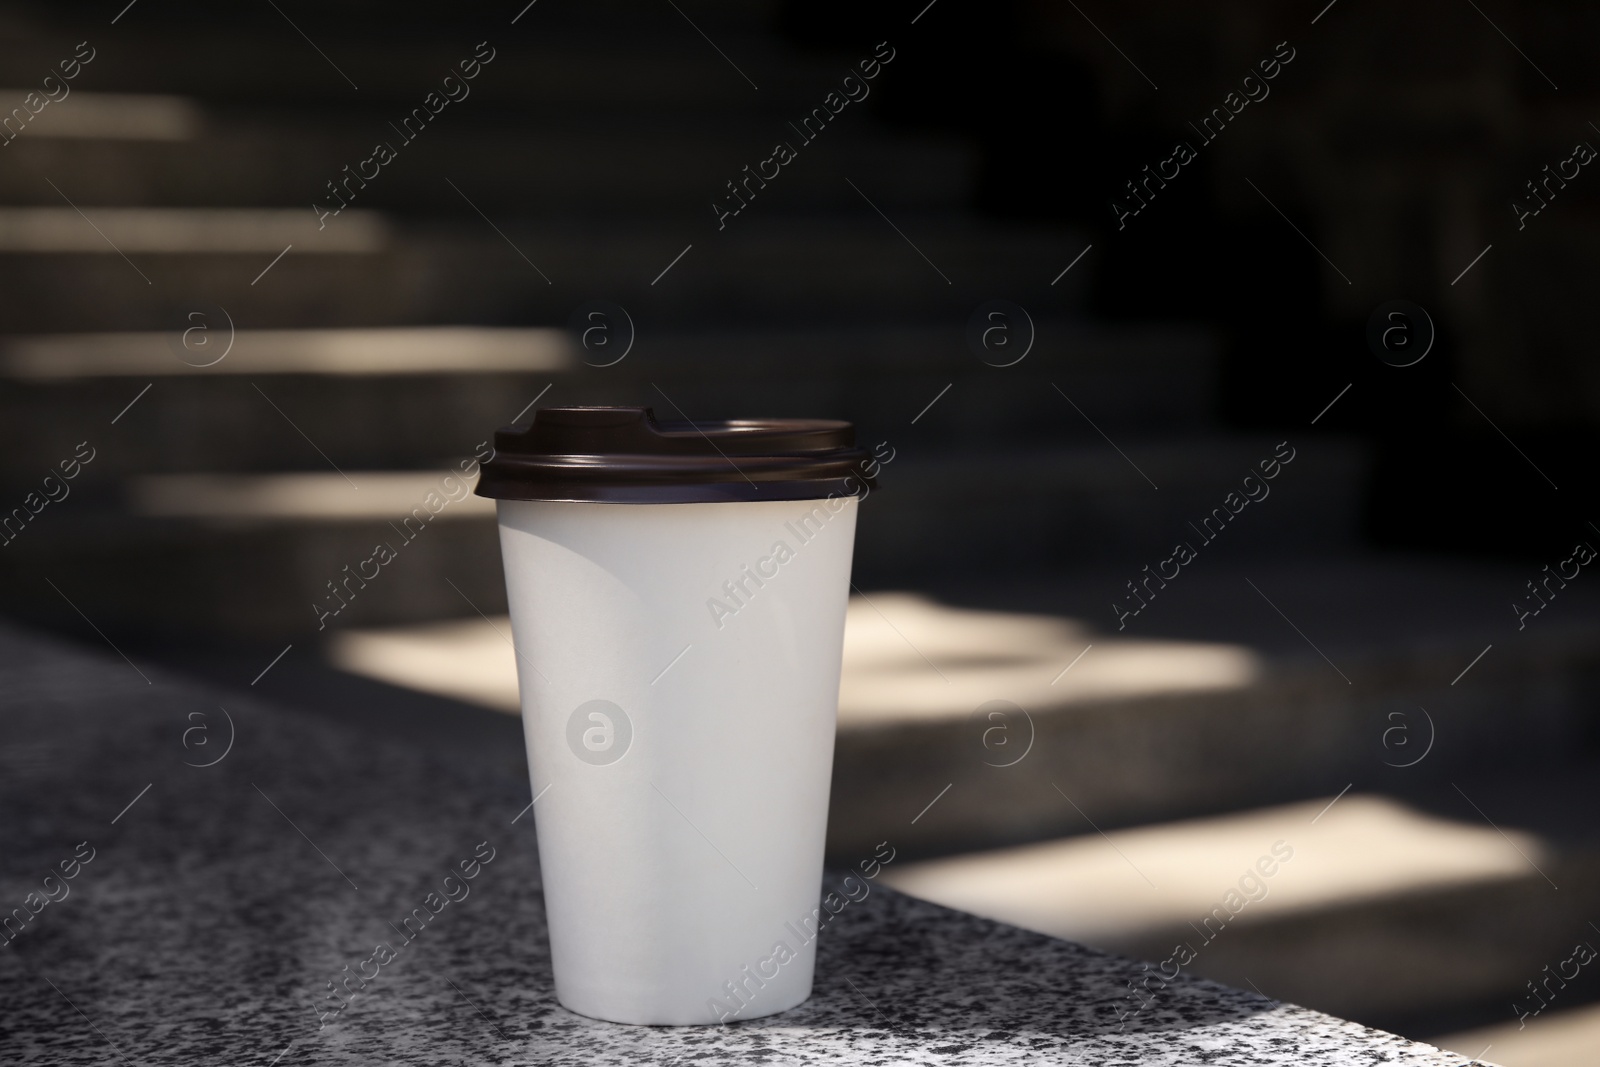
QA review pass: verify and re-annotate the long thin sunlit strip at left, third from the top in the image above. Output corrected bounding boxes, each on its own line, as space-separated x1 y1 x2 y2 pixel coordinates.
0 327 578 379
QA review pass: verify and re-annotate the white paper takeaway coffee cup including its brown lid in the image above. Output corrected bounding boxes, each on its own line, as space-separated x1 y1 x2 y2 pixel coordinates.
477 408 872 1024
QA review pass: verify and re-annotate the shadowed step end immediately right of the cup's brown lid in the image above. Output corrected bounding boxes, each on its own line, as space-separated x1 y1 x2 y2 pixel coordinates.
856 435 1368 579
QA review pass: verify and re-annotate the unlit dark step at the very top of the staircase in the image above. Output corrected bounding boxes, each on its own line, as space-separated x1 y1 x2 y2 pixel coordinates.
0 17 870 112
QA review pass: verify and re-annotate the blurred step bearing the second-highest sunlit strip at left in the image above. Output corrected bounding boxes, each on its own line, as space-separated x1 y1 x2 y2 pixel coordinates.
0 206 1086 333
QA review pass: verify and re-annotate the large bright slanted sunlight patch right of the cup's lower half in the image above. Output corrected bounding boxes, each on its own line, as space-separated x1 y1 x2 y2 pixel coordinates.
883 796 1546 947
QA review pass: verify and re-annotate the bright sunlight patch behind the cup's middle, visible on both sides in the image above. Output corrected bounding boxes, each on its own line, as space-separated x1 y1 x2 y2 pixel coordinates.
328 591 1261 716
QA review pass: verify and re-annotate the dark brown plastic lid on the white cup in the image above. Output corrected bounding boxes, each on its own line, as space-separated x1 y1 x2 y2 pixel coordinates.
477 408 877 504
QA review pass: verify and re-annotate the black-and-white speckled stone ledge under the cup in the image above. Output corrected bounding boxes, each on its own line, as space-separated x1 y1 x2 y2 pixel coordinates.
0 630 1461 1067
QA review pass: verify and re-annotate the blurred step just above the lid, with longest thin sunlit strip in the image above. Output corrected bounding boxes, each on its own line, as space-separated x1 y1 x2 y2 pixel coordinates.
0 310 1214 485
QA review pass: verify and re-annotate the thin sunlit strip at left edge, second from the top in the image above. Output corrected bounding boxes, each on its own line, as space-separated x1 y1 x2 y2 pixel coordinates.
0 205 389 252
